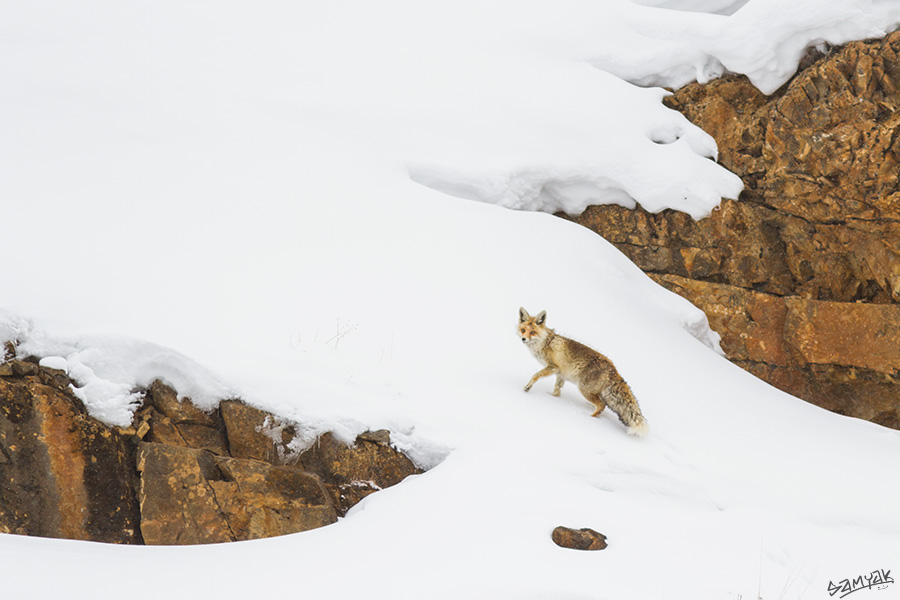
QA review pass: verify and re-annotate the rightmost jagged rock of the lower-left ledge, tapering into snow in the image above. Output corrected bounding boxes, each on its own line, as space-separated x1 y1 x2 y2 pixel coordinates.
299 432 421 515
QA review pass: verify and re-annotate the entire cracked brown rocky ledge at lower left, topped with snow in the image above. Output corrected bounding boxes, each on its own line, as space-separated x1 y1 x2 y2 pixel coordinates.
0 360 420 544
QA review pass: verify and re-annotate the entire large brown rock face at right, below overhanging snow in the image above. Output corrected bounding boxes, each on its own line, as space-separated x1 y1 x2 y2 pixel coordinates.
573 33 900 427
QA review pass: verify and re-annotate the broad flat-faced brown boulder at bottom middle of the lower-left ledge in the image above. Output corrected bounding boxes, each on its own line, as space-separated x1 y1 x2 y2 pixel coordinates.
137 443 337 544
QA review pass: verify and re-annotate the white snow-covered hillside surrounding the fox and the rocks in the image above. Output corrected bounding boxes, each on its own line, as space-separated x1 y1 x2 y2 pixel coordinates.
0 0 900 600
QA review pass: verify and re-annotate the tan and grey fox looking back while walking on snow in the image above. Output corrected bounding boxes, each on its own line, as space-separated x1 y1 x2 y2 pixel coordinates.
518 307 649 436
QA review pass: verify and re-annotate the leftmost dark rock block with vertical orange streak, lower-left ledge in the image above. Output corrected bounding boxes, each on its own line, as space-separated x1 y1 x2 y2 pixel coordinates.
0 361 141 543
